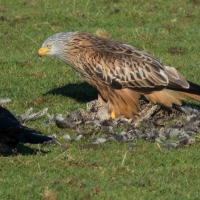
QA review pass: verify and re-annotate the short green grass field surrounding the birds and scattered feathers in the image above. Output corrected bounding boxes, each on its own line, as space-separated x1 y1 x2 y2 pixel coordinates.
0 0 200 200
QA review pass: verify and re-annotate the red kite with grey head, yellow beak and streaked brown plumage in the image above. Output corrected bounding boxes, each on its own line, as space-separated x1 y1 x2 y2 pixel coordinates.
38 32 200 118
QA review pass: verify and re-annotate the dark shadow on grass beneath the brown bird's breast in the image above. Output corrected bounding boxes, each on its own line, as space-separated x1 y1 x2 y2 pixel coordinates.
44 82 97 103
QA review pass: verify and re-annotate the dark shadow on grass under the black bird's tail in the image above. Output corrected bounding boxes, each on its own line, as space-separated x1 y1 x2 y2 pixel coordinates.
0 144 50 157
